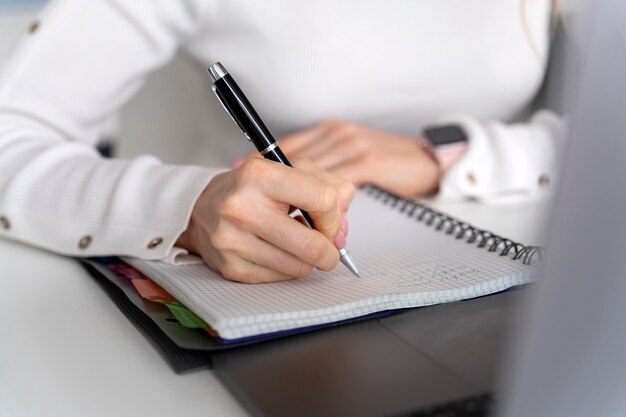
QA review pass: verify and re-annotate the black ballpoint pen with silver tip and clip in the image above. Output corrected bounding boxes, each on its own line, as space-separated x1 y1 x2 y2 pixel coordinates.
209 62 359 277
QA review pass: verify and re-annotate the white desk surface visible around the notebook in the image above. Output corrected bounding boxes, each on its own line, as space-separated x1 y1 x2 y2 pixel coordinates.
0 196 547 417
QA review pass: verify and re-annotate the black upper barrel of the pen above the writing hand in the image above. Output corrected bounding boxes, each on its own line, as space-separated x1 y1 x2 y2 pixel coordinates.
213 74 276 151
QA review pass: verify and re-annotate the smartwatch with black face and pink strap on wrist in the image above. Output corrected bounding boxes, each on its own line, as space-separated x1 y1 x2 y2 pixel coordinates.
418 125 467 174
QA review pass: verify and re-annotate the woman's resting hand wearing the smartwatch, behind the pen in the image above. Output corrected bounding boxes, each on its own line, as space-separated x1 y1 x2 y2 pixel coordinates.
279 121 439 197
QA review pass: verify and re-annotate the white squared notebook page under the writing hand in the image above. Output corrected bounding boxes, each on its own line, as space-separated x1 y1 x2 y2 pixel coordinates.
127 190 535 339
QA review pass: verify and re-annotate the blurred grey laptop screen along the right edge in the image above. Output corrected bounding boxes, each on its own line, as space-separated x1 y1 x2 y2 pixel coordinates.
498 0 626 417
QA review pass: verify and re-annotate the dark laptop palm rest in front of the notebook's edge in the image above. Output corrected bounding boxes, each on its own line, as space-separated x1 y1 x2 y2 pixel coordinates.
213 290 526 417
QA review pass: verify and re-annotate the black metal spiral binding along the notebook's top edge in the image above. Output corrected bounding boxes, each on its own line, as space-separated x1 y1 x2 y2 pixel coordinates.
362 185 543 265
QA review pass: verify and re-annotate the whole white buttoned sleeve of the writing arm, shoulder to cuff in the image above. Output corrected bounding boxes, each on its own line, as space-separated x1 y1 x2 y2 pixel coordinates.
0 0 215 259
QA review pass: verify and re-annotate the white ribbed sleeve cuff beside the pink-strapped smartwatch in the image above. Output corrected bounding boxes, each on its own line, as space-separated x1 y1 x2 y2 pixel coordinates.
439 110 565 201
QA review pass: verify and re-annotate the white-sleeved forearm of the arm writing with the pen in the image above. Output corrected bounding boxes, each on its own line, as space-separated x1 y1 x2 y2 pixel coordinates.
0 115 215 259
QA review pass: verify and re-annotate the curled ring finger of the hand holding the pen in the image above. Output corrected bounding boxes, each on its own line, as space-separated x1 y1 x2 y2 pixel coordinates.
236 234 313 278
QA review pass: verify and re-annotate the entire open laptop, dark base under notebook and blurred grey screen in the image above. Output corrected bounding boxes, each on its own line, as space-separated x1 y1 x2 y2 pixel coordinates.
213 0 626 417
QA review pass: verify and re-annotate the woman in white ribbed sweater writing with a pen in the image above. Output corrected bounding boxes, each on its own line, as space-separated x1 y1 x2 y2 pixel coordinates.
0 0 560 282
